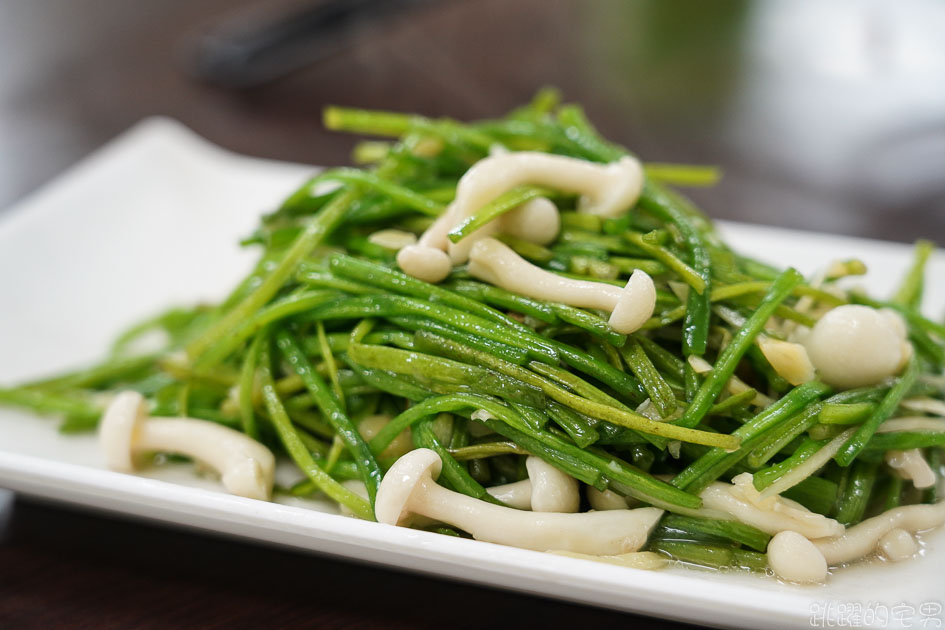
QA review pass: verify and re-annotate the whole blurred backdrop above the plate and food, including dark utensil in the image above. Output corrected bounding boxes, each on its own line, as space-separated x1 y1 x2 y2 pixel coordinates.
0 0 945 242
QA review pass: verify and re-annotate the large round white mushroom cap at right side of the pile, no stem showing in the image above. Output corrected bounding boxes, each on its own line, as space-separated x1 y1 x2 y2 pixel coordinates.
801 304 912 388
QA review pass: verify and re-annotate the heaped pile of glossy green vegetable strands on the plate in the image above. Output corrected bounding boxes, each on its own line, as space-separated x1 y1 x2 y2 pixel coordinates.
0 91 945 570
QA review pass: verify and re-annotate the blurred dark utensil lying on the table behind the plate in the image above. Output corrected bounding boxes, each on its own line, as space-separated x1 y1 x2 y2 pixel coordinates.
193 0 438 89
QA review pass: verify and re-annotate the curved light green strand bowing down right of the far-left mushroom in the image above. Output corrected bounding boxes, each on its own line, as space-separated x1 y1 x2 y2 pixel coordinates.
259 339 374 520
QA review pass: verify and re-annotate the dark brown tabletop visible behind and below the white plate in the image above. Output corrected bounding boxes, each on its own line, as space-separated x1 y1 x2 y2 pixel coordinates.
0 0 945 628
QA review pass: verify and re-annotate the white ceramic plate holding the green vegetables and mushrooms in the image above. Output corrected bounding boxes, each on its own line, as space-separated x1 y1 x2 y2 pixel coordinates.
0 119 945 628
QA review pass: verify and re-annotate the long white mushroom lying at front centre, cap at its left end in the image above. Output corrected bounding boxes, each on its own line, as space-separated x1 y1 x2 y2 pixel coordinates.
374 449 663 555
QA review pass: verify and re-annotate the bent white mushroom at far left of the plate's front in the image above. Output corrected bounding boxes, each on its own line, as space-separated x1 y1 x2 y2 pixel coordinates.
99 391 275 500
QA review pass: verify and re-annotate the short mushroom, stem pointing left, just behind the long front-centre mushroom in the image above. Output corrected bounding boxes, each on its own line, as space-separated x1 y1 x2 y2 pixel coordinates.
487 455 581 512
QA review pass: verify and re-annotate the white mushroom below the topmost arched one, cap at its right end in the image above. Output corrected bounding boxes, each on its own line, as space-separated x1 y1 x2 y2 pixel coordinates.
469 238 656 334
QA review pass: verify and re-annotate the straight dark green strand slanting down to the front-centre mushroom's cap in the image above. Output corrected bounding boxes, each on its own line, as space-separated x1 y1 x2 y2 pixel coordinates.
276 330 382 505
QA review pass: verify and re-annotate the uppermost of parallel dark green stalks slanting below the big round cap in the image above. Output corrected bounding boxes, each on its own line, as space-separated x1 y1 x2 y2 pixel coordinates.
672 381 830 492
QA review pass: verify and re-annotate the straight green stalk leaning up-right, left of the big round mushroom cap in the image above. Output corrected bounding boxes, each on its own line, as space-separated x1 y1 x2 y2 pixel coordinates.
676 269 803 427
